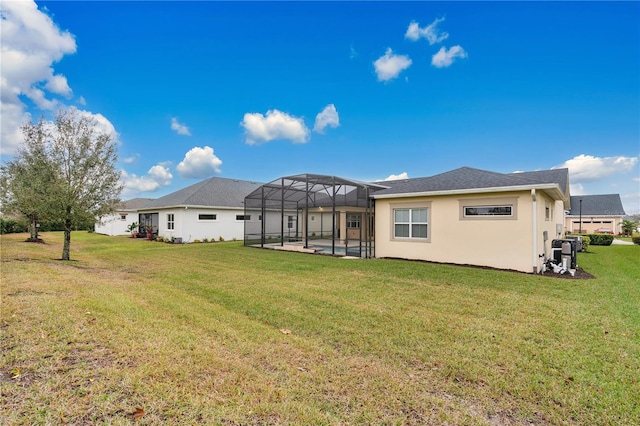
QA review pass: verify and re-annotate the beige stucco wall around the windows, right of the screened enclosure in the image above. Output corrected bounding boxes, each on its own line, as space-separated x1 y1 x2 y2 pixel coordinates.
375 191 563 272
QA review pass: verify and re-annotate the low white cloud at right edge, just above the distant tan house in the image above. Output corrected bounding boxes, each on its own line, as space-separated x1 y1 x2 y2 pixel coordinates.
553 154 638 183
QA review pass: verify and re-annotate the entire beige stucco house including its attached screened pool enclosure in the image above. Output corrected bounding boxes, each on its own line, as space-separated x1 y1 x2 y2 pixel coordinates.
245 167 570 273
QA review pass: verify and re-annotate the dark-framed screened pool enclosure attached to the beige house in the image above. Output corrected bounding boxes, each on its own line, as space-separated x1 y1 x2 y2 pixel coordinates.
244 174 386 257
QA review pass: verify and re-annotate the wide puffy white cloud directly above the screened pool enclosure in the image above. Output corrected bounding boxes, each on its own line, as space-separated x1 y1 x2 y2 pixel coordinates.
240 109 310 145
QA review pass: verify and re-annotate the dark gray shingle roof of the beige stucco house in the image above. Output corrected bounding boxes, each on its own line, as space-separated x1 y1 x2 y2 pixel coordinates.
373 167 568 197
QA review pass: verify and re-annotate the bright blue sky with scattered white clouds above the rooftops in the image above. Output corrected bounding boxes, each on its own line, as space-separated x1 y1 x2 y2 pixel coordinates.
0 0 640 214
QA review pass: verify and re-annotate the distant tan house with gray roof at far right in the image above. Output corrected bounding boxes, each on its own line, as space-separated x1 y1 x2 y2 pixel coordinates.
565 194 626 234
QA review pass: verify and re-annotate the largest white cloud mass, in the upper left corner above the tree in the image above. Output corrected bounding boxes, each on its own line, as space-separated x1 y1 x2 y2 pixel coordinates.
0 1 76 155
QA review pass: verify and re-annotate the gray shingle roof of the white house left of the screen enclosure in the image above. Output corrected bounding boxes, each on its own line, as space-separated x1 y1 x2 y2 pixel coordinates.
144 177 262 210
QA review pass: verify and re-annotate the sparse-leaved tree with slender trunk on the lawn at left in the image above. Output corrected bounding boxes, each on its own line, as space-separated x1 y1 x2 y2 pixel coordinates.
0 108 122 260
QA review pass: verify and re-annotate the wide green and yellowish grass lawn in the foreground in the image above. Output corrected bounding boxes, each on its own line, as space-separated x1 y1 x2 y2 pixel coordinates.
0 232 640 425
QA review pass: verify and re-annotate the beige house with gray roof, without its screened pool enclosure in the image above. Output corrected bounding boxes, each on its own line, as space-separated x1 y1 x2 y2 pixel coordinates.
372 167 570 273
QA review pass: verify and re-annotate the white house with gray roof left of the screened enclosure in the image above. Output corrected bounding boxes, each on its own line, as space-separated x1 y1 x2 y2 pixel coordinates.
138 177 261 243
